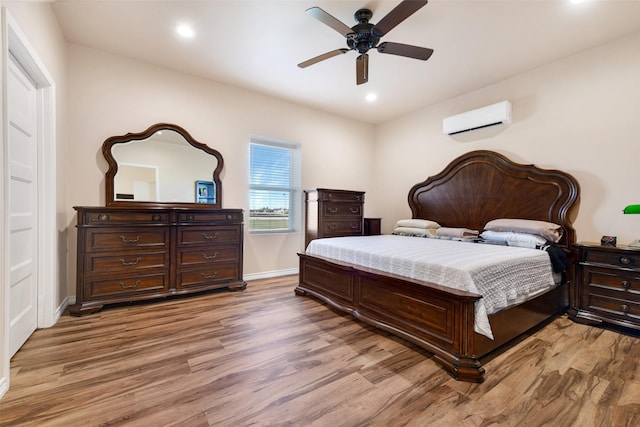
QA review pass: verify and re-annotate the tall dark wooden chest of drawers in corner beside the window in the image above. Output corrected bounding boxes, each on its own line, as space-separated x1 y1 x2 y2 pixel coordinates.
304 188 364 248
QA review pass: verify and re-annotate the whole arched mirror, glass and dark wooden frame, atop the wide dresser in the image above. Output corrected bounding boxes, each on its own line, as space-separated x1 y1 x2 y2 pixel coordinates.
102 123 224 209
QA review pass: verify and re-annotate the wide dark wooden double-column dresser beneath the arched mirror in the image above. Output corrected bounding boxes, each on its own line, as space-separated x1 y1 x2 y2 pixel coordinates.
69 207 246 315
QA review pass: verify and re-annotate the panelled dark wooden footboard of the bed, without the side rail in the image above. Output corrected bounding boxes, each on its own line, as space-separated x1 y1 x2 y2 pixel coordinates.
295 254 484 382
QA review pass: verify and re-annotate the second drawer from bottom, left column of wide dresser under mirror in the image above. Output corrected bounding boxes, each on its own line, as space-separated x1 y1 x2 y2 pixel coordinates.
85 251 169 275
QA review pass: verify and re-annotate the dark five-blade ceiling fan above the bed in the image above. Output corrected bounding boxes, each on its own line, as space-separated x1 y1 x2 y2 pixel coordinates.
298 0 433 85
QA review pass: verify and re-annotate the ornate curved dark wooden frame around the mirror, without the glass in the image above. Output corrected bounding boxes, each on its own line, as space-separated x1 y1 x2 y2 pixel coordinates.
102 123 224 209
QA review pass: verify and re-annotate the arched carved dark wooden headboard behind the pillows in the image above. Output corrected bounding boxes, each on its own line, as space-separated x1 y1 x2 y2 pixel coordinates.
409 150 580 248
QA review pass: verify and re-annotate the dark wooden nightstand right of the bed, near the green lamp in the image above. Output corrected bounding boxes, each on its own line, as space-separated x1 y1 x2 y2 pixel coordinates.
568 243 640 330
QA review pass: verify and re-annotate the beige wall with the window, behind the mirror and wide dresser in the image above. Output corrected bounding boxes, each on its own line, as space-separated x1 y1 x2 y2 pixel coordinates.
67 45 374 288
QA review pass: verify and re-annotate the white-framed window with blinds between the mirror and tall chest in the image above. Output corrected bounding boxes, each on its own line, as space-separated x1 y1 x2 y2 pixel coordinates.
249 136 300 233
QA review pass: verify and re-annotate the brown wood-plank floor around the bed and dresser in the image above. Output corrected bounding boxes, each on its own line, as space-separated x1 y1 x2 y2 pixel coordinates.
0 276 640 427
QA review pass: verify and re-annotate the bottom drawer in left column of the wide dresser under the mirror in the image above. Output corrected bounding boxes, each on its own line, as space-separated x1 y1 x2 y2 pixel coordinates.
86 272 168 300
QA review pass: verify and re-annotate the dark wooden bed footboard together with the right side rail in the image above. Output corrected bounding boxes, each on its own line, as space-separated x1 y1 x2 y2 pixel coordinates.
295 253 567 382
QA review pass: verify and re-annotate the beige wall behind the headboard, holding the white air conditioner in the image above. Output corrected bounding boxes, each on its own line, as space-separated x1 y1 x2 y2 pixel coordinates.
367 33 640 247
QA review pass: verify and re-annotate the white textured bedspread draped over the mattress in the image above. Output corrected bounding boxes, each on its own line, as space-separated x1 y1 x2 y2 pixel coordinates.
306 235 555 339
